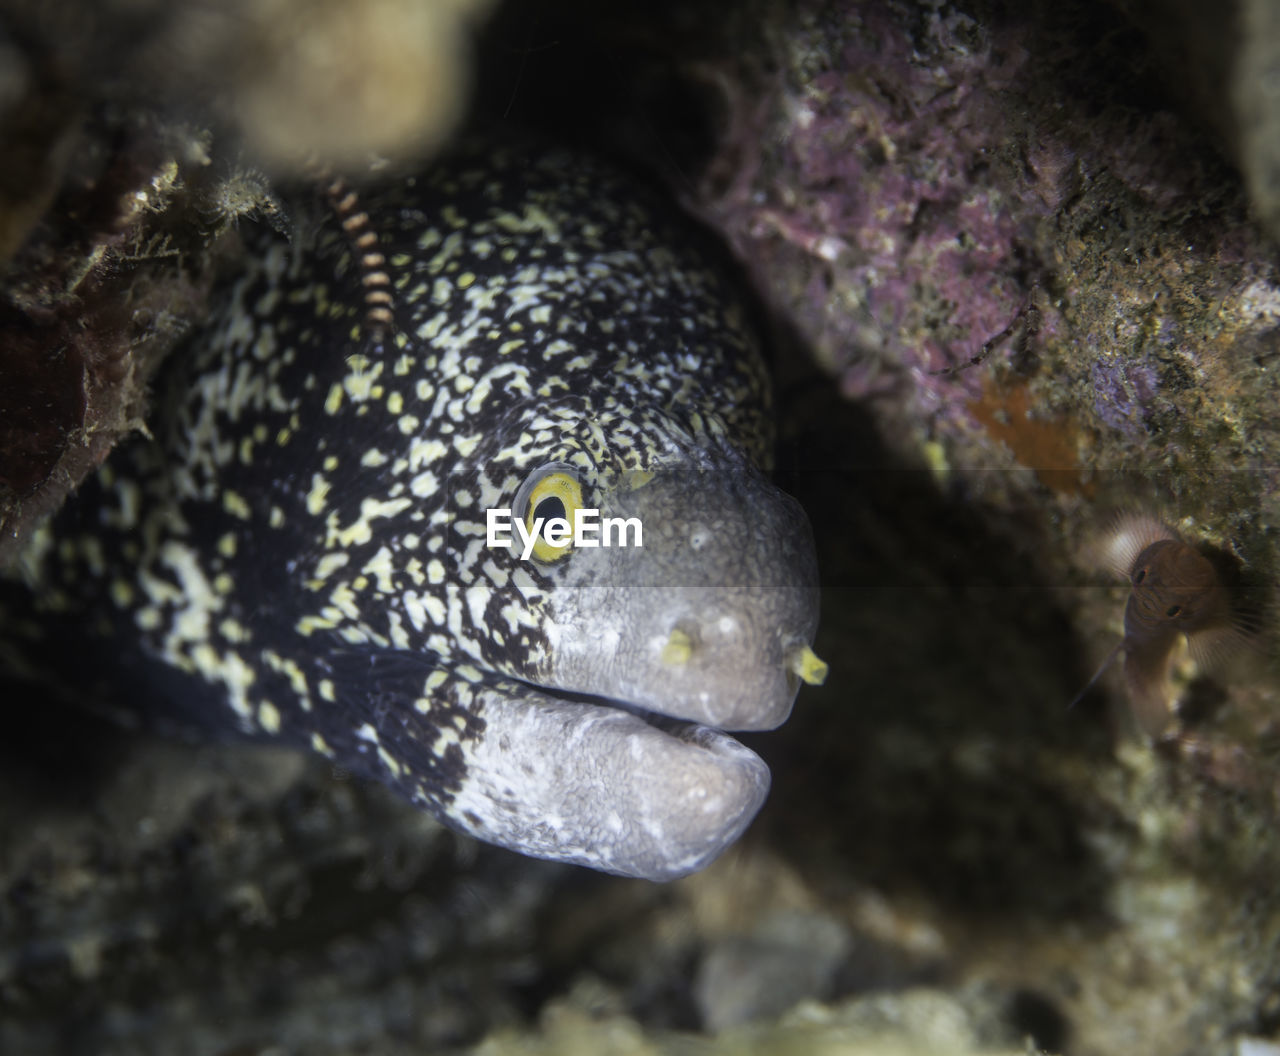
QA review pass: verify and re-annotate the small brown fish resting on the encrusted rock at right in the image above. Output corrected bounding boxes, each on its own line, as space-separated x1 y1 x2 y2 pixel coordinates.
1073 513 1247 737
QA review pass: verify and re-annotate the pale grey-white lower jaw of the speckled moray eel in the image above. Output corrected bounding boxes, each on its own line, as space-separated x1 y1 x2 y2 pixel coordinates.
449 686 769 881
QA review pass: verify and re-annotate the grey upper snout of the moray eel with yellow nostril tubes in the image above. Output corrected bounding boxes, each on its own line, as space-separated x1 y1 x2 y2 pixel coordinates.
530 471 823 731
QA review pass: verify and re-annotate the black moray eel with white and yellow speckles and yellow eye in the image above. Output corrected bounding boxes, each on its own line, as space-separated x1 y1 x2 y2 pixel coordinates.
5 142 824 879
